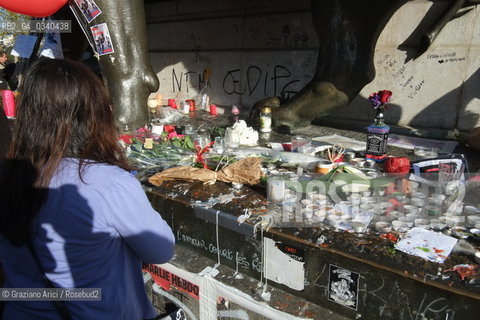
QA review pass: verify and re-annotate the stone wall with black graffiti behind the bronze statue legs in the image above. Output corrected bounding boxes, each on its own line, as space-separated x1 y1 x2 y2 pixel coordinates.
146 0 480 130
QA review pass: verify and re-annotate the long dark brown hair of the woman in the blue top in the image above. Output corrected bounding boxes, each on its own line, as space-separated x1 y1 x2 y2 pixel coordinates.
0 59 130 245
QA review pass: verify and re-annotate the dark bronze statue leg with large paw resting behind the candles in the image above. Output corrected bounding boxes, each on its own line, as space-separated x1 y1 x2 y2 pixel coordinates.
253 0 407 128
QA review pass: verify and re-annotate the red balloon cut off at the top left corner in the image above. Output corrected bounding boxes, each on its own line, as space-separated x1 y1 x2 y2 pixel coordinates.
0 0 67 17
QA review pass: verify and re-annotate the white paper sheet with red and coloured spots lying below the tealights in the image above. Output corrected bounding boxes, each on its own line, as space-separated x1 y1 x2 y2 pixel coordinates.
395 228 457 263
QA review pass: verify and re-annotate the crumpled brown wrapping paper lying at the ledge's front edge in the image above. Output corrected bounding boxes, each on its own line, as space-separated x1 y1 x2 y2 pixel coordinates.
148 157 262 187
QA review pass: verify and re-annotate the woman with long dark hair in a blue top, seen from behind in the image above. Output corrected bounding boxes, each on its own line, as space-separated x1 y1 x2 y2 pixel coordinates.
0 59 174 320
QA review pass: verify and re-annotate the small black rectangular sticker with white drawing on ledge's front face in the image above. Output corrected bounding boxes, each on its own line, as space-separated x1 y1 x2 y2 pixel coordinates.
328 264 360 310
